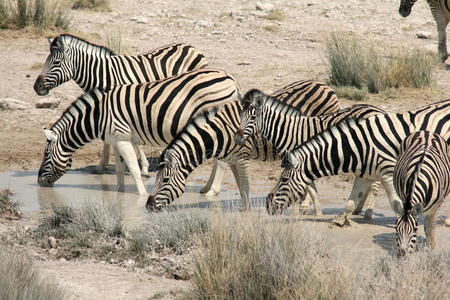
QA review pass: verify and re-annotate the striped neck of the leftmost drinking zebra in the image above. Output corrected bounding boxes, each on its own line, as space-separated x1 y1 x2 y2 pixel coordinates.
51 94 103 153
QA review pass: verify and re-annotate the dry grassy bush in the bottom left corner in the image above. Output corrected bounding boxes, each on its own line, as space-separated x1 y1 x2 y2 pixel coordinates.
0 249 70 300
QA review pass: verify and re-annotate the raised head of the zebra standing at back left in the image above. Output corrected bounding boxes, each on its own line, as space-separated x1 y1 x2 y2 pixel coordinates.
34 36 74 96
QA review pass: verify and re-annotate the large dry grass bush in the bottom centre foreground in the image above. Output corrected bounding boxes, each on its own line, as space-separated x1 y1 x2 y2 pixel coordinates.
191 214 360 299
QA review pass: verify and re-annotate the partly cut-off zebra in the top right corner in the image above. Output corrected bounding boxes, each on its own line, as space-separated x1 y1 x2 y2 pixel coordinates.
398 0 450 62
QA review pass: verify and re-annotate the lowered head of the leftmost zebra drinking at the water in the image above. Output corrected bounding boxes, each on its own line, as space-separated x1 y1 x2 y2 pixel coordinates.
38 129 72 187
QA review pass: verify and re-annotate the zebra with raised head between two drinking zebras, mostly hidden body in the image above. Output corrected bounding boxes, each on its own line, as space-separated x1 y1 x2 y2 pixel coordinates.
236 89 386 219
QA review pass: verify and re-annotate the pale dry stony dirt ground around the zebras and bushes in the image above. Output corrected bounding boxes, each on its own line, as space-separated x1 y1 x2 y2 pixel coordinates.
0 0 450 299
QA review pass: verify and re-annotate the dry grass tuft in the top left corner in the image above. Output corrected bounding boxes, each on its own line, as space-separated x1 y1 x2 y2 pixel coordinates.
0 0 71 29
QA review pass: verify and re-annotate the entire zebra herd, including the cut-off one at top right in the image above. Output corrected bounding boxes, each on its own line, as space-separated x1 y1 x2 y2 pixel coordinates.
34 0 450 255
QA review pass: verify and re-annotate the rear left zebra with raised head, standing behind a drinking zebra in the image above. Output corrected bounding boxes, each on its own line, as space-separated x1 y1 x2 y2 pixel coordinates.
34 34 208 173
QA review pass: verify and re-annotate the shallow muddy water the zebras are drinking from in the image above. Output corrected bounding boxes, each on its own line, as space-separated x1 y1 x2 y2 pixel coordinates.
0 167 450 255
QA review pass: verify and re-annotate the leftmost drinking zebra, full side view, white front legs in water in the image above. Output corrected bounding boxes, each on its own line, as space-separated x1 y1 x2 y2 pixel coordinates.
38 69 239 194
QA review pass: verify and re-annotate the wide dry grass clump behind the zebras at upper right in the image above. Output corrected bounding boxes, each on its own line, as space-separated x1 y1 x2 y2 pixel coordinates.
326 33 435 93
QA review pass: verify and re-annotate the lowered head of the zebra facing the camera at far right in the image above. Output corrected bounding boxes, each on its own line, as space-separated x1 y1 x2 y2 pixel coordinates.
395 203 422 256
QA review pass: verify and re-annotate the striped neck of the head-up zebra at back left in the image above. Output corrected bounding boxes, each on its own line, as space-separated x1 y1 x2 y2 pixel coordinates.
73 46 116 92
